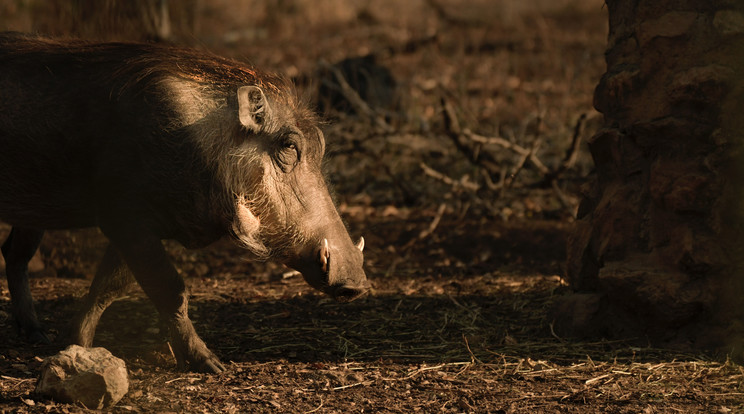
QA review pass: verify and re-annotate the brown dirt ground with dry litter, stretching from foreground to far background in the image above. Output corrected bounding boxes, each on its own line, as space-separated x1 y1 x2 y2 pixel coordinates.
0 0 744 413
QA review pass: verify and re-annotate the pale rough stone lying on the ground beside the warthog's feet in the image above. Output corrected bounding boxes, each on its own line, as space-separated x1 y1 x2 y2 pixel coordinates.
35 345 129 410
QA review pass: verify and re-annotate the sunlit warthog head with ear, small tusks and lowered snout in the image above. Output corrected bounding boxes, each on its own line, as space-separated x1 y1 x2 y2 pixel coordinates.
223 85 368 301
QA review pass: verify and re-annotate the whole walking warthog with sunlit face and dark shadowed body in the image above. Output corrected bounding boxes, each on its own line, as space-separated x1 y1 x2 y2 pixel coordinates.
0 34 367 371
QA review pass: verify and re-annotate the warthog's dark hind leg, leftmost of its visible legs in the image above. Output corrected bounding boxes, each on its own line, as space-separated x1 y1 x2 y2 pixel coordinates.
2 227 49 343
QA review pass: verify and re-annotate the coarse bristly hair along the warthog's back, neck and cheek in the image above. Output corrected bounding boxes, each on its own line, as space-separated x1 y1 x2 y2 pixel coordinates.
0 33 324 258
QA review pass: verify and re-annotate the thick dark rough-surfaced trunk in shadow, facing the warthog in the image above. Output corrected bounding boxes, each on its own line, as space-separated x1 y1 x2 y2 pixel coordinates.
555 0 744 352
